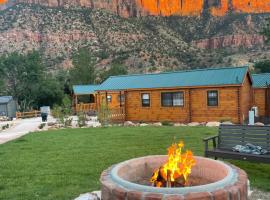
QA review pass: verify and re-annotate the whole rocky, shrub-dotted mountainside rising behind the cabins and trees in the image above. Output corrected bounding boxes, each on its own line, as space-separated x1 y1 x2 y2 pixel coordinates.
0 0 270 72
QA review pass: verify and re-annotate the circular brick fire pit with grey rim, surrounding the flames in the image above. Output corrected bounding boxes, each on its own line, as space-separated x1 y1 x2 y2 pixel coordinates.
100 156 247 200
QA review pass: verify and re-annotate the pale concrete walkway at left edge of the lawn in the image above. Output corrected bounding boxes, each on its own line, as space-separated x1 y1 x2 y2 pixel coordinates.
0 117 47 144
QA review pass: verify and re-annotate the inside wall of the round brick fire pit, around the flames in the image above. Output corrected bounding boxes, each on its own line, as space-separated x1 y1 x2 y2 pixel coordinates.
117 156 229 187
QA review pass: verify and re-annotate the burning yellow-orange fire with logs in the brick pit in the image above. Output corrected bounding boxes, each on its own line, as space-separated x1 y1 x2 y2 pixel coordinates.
150 141 195 187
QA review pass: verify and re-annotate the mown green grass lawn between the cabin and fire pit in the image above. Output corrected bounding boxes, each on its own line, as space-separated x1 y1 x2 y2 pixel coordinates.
0 127 270 200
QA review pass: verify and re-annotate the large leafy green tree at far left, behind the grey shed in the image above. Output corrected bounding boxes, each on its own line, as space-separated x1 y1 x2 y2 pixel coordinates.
0 51 63 111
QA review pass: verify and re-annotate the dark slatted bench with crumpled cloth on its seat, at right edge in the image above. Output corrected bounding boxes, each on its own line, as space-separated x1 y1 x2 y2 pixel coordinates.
203 125 270 163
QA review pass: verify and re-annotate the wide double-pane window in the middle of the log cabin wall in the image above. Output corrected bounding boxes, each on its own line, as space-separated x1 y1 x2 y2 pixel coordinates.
161 92 184 107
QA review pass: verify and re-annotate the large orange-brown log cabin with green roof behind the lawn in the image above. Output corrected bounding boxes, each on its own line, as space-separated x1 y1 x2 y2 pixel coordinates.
96 67 253 123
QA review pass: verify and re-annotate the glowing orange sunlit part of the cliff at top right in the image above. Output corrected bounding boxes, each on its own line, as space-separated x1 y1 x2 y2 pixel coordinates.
137 0 270 16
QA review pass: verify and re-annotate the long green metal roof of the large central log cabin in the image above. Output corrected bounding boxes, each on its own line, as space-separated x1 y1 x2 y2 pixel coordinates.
97 67 248 90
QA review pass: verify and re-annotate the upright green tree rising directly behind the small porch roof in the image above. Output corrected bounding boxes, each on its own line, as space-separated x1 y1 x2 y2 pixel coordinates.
70 48 96 85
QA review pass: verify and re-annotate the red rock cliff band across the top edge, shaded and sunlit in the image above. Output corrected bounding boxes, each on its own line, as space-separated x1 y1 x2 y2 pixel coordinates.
0 0 270 17
